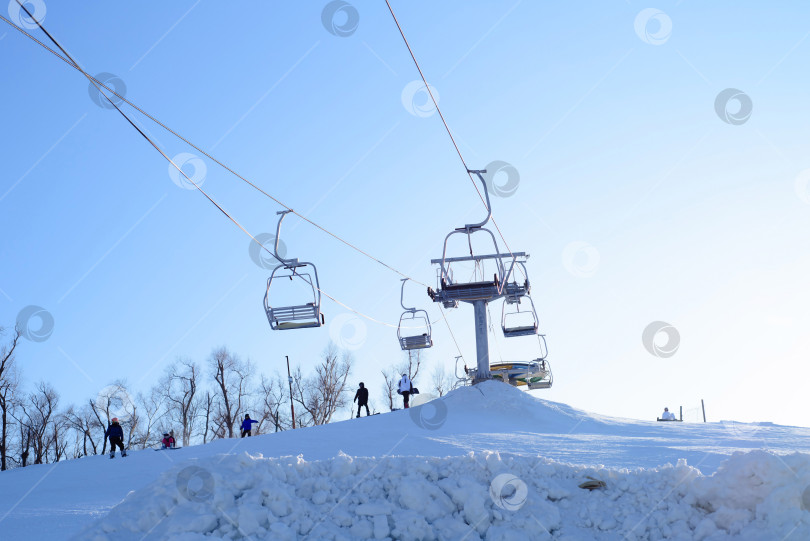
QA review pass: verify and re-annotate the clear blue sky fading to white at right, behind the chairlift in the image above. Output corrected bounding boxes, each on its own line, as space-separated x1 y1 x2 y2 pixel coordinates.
0 0 810 425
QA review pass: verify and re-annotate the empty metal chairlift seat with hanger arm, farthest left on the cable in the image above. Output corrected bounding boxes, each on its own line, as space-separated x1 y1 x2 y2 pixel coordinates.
264 210 325 331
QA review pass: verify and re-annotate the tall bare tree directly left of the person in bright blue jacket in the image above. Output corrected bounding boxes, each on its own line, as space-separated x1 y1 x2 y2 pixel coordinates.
209 347 253 438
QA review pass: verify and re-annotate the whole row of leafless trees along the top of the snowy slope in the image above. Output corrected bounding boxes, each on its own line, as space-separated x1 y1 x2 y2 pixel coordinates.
0 327 452 470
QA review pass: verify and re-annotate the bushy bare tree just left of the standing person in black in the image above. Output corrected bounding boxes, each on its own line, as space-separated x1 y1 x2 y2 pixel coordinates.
293 342 354 426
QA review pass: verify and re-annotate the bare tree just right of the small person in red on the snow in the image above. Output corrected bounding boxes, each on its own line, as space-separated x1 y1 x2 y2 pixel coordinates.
161 359 200 446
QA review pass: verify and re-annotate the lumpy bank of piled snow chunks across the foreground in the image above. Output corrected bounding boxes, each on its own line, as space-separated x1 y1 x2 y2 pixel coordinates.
77 451 810 541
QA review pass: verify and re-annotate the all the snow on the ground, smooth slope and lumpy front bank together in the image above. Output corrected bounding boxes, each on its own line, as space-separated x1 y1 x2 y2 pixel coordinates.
0 382 810 541
